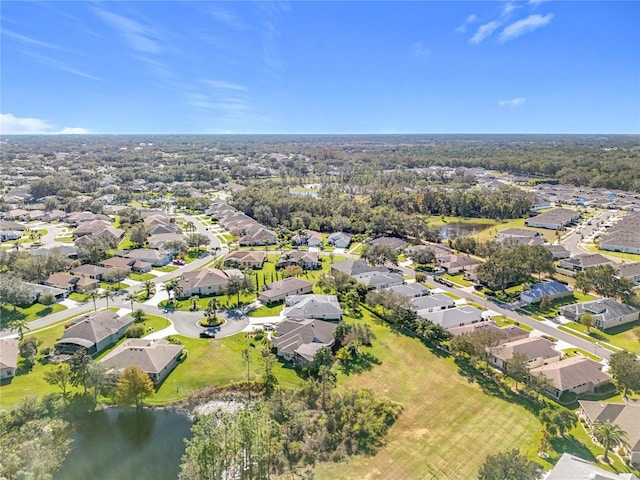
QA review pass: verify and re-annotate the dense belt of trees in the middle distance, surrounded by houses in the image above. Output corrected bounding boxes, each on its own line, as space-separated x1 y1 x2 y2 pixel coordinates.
231 185 532 237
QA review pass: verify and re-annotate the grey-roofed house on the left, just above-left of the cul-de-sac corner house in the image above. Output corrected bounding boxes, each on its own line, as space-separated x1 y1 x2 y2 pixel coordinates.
55 310 134 355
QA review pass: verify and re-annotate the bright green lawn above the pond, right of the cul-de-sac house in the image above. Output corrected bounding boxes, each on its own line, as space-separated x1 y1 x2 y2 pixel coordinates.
145 335 302 405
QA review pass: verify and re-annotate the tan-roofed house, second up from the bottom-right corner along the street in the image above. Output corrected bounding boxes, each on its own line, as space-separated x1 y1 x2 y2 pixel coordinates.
530 355 611 400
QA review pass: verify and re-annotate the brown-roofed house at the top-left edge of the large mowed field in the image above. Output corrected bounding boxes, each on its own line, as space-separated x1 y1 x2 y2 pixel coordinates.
271 319 338 365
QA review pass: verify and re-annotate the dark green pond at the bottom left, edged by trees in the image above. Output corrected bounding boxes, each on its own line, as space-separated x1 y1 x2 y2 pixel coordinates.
54 408 191 480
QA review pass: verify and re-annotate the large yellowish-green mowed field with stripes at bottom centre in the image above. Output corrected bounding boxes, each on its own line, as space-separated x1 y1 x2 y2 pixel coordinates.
315 311 541 480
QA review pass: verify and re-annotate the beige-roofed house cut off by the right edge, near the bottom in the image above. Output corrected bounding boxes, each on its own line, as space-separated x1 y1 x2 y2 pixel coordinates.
578 400 640 466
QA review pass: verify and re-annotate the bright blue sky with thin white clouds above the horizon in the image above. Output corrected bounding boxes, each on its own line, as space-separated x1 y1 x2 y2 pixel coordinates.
0 0 640 133
